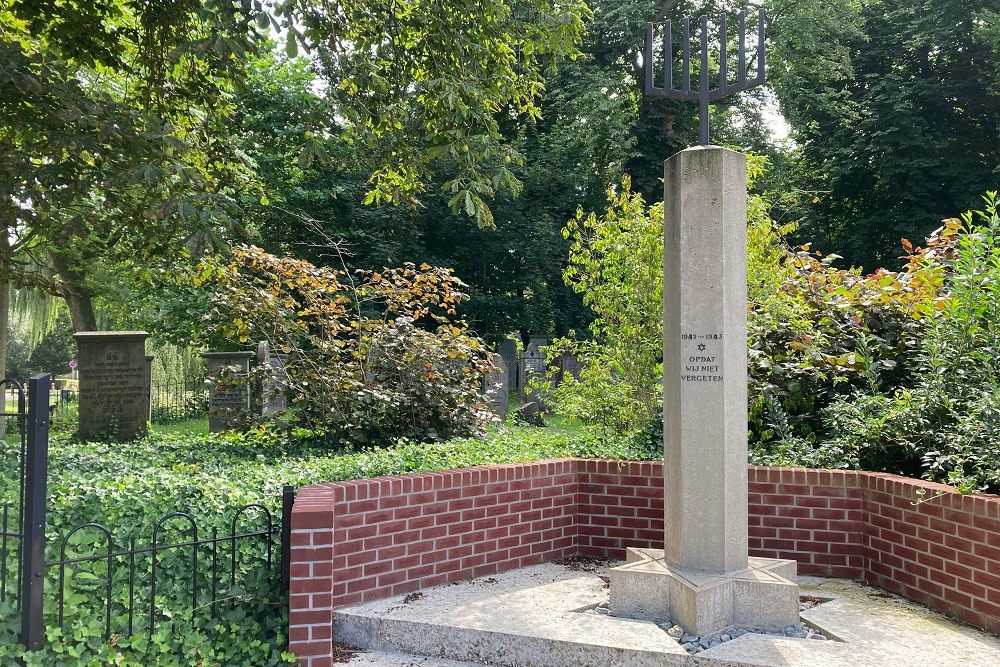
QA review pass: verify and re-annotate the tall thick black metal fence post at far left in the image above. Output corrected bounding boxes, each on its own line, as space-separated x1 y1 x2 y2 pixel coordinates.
21 373 52 651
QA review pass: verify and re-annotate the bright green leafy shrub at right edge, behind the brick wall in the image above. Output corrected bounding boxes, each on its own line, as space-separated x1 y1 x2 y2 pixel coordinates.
816 192 1000 490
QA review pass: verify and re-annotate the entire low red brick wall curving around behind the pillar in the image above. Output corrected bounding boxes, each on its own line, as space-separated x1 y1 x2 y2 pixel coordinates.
289 459 1000 667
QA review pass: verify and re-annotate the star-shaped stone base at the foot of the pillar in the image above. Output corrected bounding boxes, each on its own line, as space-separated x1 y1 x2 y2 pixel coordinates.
608 548 799 636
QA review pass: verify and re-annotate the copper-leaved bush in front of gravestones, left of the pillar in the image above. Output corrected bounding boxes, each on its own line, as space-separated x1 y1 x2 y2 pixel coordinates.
197 246 492 445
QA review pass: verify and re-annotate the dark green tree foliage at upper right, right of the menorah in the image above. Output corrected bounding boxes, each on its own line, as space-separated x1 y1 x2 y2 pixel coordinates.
770 0 1000 269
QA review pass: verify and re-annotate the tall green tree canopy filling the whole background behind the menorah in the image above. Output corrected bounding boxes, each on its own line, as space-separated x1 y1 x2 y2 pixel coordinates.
0 0 1000 342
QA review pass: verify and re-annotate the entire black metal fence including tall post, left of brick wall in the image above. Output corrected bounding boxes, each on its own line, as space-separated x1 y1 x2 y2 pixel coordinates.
0 375 295 650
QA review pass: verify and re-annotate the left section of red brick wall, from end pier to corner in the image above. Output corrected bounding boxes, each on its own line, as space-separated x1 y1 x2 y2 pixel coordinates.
289 459 579 667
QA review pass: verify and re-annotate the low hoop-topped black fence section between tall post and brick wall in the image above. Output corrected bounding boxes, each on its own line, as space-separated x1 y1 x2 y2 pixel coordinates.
46 487 295 639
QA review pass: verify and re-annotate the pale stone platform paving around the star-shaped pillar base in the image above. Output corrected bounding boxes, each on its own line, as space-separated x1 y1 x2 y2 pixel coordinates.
334 563 1000 667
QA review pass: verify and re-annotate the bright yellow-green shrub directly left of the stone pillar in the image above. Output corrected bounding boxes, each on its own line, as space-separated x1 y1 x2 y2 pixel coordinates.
537 177 663 433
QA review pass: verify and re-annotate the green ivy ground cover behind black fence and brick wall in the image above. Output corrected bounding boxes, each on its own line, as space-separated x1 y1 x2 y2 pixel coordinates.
0 426 655 667
